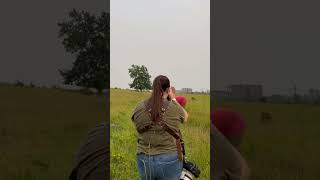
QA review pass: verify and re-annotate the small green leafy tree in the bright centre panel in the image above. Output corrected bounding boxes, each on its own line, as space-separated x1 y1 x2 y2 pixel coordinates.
129 65 151 91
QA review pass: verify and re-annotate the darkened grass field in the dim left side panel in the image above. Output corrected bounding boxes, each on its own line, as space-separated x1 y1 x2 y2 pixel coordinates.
0 85 107 180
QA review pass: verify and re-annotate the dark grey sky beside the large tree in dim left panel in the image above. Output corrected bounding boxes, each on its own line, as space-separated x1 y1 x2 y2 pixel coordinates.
0 0 107 85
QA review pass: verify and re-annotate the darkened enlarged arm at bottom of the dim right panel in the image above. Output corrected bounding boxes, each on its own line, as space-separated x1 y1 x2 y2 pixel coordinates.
210 112 250 180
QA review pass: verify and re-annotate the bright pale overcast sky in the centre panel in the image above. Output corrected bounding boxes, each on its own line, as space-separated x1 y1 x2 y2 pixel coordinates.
110 0 210 90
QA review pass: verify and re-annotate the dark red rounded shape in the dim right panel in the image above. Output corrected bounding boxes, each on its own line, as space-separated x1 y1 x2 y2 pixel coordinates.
212 108 245 150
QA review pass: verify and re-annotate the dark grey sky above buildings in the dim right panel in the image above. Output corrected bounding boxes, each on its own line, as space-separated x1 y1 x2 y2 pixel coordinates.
211 0 320 94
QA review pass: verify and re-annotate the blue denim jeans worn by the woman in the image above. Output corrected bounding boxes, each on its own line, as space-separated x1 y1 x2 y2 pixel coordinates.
137 153 183 180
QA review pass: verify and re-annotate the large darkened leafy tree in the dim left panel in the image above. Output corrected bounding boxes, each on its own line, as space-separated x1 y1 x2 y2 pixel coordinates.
58 9 110 93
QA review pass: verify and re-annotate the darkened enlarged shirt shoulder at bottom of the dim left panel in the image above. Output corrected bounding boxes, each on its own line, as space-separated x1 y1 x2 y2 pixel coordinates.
69 124 110 180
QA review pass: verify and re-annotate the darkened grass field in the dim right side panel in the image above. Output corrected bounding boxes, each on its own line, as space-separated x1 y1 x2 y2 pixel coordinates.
218 103 320 180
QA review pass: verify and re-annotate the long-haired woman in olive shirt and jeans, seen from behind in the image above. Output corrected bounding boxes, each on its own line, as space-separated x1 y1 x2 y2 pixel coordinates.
132 75 188 180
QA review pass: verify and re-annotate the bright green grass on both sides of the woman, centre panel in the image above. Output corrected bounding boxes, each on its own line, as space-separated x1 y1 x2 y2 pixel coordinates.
110 89 210 180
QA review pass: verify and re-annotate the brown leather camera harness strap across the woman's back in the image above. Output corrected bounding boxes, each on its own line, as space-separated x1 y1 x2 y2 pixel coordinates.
138 101 185 161
